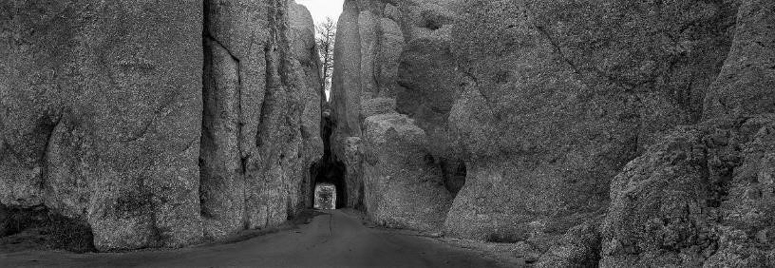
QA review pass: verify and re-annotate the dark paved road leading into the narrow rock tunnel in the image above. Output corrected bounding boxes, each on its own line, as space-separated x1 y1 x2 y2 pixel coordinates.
0 211 510 267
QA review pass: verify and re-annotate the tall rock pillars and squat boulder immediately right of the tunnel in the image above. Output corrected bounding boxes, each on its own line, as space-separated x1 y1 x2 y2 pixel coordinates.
330 0 457 229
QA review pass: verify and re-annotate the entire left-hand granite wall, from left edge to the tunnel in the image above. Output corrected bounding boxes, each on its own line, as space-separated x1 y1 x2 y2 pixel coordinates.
0 0 321 250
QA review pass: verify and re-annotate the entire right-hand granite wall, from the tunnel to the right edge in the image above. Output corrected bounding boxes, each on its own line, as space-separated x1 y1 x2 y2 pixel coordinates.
331 0 775 267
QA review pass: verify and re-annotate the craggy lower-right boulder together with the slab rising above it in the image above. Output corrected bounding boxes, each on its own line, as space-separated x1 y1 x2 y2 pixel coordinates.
600 0 775 267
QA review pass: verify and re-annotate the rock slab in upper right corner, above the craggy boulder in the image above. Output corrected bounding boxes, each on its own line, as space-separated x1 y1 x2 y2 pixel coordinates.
704 1 775 118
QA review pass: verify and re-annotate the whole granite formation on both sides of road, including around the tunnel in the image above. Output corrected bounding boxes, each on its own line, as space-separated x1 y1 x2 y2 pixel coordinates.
0 0 775 267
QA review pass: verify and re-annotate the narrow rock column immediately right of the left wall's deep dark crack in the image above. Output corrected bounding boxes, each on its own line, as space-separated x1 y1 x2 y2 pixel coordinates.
199 0 249 237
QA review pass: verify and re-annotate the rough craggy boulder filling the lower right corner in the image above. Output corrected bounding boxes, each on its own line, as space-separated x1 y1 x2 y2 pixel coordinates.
601 114 775 267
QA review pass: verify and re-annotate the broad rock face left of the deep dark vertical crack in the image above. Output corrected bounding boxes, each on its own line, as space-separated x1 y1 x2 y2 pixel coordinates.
0 1 202 250
